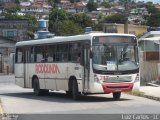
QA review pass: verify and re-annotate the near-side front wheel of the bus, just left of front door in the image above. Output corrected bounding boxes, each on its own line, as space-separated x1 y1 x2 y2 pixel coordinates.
72 80 80 100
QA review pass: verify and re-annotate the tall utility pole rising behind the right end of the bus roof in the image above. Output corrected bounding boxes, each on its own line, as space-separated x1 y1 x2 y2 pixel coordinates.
124 0 130 34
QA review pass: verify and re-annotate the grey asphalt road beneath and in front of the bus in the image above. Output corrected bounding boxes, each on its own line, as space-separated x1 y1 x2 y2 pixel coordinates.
0 76 160 119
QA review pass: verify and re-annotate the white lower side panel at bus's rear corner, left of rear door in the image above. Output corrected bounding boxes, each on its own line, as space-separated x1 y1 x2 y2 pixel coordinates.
15 63 25 87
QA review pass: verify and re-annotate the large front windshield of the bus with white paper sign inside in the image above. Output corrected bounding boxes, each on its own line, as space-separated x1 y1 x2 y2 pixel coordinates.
92 36 138 71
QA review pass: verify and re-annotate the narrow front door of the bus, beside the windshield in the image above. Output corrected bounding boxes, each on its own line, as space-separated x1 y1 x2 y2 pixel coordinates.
82 44 90 92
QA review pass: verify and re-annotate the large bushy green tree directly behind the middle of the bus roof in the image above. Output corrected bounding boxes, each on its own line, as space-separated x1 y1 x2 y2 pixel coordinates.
49 9 83 35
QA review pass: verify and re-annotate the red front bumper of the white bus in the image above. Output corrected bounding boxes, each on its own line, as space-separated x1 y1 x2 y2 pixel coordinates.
102 83 133 93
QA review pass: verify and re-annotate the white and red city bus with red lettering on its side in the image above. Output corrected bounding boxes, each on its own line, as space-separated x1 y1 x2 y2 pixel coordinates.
15 33 139 100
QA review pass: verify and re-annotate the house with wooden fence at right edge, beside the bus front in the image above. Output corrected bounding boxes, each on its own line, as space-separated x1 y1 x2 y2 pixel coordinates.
139 31 160 83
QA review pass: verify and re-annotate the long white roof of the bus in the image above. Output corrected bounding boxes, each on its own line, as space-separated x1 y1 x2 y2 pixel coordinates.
16 33 135 46
